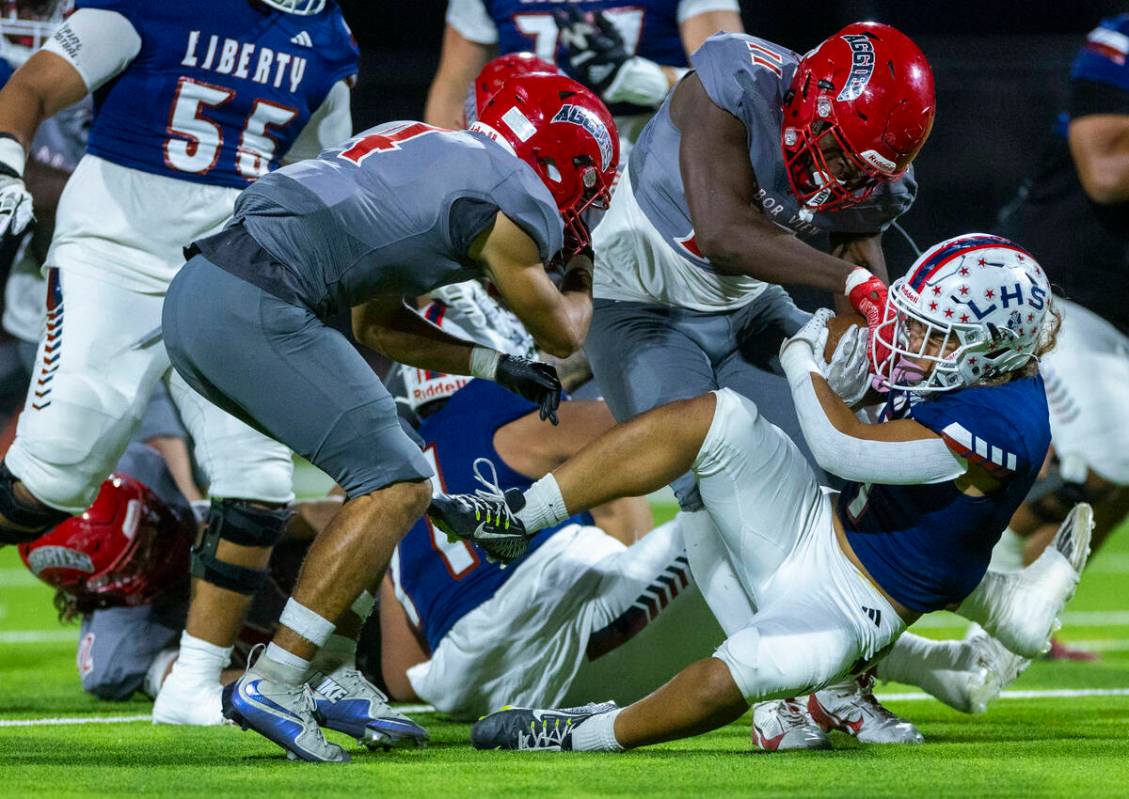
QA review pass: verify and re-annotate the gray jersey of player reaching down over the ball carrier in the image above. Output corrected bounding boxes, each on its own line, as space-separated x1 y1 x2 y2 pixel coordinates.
629 34 917 269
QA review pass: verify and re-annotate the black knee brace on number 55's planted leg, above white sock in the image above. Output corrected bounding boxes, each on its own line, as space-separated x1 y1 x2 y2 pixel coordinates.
192 499 292 596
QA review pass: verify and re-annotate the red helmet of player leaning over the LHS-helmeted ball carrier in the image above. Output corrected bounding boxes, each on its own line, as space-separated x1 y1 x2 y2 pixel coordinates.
780 23 937 211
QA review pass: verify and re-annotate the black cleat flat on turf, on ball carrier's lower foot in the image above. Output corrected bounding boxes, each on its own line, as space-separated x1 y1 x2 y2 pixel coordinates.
471 702 618 752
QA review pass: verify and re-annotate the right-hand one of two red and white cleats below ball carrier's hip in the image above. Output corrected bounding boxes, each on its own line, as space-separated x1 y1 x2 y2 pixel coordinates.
807 674 925 744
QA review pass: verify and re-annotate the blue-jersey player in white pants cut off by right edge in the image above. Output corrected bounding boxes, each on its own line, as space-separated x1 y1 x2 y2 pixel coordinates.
999 14 1129 658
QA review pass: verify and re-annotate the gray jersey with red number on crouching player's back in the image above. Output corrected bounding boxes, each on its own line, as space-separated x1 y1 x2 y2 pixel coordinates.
229 122 563 318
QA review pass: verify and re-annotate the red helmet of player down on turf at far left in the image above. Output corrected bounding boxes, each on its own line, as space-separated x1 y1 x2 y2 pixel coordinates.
19 474 195 607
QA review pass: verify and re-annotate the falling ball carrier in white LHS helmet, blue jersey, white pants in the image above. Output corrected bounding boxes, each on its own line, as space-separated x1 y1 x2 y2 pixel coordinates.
430 235 1089 750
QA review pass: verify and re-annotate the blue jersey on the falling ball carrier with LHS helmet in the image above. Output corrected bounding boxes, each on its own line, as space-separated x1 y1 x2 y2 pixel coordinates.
839 376 1051 613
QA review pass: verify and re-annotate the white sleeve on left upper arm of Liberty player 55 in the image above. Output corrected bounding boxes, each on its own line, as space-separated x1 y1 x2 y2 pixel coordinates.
43 8 141 91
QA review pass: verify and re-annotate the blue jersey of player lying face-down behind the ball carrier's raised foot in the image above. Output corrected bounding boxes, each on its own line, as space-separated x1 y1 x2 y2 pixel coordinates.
393 380 590 651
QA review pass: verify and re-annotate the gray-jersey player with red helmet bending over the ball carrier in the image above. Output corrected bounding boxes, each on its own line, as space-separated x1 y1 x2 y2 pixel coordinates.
585 23 935 740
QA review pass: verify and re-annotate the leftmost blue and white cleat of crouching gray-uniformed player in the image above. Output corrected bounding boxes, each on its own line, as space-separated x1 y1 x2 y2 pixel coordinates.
217 670 350 763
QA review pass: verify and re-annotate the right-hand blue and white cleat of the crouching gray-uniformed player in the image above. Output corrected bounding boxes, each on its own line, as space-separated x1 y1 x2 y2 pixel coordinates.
307 668 428 749
